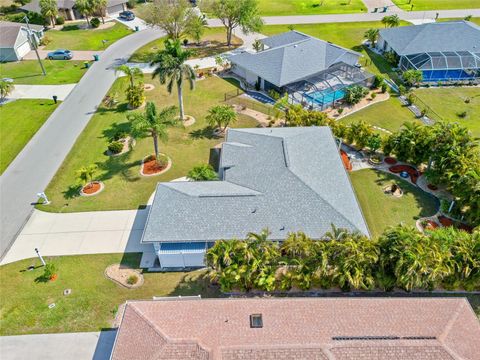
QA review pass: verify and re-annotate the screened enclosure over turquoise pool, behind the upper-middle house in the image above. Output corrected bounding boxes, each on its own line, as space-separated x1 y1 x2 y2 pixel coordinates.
285 63 375 110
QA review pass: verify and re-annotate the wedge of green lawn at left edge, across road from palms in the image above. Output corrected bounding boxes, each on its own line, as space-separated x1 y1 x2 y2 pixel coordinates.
0 99 58 174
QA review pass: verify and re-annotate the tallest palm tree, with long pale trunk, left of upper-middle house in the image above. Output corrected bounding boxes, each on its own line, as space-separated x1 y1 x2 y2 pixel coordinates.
151 39 196 120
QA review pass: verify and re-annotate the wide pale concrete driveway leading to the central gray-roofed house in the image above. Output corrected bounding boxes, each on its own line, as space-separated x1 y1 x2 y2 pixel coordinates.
0 207 153 265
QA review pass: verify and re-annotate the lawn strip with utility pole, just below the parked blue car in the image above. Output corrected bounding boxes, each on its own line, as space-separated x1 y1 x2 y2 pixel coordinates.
0 60 87 85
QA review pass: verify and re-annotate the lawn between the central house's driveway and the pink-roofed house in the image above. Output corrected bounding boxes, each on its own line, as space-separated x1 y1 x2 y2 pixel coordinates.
0 254 217 335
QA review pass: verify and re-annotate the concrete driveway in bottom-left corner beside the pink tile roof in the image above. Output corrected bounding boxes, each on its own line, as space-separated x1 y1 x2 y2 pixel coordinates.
0 330 116 360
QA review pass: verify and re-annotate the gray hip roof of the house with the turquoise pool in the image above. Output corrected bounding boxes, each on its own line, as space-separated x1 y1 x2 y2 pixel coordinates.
229 31 361 87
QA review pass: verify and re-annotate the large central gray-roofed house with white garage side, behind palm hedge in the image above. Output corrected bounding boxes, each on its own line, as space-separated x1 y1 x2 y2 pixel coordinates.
141 127 369 268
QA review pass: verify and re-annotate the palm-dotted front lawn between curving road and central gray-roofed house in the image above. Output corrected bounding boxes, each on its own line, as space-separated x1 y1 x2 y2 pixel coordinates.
40 77 257 212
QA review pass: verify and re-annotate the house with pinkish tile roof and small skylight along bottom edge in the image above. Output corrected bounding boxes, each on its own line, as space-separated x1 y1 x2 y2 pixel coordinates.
110 298 480 360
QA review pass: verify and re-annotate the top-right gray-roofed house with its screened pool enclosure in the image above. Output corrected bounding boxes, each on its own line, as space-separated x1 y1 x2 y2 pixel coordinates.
376 20 480 82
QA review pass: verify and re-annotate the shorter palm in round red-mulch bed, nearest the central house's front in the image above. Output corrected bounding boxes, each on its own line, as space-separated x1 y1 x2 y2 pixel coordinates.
127 101 178 161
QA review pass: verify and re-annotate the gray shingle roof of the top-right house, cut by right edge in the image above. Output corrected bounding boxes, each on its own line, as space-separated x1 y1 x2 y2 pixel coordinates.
380 21 480 55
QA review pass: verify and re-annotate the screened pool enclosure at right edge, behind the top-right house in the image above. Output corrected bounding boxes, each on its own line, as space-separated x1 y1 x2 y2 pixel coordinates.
399 51 480 82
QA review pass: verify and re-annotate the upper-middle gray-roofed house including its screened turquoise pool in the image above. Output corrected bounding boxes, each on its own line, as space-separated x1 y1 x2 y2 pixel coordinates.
229 31 374 110
